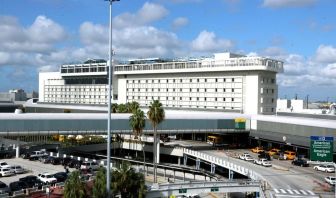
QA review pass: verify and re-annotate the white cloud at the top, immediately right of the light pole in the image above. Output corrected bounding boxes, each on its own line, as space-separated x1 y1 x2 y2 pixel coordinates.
113 2 169 29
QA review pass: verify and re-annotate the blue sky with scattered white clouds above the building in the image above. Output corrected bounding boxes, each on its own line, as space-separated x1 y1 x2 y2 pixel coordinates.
0 0 336 101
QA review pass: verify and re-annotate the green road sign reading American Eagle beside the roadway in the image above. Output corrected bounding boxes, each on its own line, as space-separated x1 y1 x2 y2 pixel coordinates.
310 136 334 162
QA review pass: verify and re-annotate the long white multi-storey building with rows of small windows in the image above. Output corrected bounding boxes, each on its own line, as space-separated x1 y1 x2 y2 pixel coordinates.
39 53 283 114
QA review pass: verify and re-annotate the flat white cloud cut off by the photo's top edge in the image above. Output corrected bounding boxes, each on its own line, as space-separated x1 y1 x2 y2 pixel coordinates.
263 0 317 8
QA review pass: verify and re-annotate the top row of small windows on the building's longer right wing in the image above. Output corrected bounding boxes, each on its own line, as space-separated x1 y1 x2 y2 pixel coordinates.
126 78 237 84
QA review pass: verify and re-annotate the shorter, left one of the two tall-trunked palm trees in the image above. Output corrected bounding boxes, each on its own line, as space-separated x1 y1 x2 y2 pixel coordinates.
129 108 146 171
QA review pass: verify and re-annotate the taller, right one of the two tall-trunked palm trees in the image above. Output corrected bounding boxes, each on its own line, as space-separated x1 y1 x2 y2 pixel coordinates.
147 100 165 183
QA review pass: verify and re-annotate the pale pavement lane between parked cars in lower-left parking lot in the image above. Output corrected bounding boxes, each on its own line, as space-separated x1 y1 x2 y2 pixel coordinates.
0 158 75 185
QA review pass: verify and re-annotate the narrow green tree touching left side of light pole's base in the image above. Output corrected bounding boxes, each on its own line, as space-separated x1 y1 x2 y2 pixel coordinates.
92 167 107 198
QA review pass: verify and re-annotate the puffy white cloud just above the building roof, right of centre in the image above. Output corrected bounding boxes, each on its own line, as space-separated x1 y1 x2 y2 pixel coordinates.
191 30 234 52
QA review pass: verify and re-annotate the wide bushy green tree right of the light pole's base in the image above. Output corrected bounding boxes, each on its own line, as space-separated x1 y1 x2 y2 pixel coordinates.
111 161 146 198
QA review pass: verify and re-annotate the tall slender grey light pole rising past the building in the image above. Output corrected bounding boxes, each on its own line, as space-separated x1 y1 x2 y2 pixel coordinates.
105 0 120 198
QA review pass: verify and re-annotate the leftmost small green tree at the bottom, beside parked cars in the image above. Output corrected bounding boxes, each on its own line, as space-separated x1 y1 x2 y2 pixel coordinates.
64 171 86 198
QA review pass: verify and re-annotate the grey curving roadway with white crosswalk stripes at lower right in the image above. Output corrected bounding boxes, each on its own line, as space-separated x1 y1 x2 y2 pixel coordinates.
202 150 334 197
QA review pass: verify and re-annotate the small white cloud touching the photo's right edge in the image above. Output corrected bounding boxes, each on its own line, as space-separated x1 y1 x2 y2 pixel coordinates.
315 45 336 63
